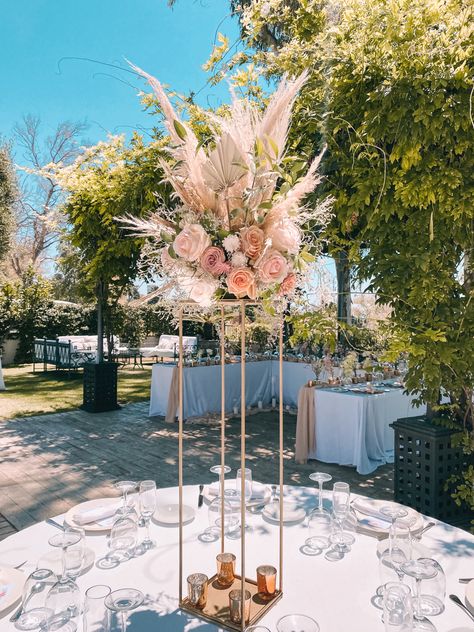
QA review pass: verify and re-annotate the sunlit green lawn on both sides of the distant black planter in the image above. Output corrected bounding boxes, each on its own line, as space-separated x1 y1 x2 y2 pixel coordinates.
0 364 151 421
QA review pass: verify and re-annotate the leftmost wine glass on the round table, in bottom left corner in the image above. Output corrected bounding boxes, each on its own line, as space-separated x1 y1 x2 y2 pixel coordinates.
15 568 57 630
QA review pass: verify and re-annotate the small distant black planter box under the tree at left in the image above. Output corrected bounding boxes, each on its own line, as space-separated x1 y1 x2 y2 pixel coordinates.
81 362 120 413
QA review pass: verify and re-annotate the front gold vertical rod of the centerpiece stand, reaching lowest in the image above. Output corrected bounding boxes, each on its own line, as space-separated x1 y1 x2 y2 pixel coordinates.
240 301 247 632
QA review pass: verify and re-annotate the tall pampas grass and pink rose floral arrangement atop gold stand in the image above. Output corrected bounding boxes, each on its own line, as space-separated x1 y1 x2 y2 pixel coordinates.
121 67 330 307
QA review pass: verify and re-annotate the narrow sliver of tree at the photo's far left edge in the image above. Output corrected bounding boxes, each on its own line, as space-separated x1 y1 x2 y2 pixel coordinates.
0 145 18 272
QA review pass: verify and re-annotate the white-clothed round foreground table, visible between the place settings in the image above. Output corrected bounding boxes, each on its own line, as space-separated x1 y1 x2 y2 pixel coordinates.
0 486 474 632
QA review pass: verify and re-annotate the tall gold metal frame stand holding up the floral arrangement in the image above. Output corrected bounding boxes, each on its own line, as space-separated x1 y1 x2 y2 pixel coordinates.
178 300 283 632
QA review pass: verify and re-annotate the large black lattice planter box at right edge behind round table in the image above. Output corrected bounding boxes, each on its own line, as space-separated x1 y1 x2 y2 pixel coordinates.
392 416 472 524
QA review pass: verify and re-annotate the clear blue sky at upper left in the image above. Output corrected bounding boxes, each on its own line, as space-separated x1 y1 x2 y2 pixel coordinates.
0 0 238 142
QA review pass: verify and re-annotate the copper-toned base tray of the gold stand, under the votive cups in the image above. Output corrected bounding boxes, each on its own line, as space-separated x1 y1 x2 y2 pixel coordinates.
180 575 283 630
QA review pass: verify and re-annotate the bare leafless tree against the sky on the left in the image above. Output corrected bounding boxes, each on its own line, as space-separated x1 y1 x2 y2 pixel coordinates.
10 115 86 277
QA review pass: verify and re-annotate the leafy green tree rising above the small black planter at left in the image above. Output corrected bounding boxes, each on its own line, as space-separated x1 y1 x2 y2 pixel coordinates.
47 135 171 362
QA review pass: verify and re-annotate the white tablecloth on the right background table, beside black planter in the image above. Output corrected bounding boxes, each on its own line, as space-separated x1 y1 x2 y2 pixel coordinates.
309 389 424 474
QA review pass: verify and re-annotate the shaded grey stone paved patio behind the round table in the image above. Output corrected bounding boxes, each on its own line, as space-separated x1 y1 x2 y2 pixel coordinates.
0 402 393 539
